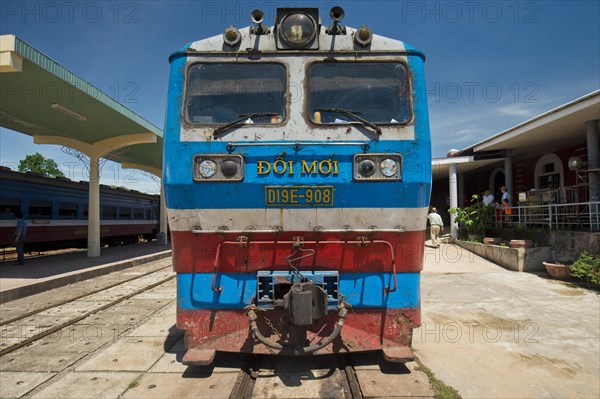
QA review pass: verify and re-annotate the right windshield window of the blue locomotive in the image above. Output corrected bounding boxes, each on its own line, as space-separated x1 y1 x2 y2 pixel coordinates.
309 62 410 124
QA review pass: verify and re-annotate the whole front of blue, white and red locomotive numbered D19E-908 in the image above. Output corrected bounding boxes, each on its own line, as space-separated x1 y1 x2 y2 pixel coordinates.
163 7 431 365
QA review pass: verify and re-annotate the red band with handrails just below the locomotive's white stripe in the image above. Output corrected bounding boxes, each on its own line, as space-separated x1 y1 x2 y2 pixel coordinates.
171 230 425 273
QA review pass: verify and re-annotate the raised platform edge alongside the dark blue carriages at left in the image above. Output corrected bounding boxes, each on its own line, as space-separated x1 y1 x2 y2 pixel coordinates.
0 242 171 303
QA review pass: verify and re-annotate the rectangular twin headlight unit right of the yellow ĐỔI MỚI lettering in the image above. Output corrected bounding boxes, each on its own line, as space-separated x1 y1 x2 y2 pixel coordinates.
353 153 402 181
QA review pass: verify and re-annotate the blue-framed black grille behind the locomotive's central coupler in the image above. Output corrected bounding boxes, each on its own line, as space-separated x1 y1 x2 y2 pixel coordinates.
256 271 339 310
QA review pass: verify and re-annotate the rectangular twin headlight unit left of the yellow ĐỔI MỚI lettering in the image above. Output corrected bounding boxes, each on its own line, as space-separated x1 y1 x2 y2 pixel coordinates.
194 154 244 182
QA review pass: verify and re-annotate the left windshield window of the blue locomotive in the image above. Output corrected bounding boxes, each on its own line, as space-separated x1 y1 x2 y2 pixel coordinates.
185 63 286 125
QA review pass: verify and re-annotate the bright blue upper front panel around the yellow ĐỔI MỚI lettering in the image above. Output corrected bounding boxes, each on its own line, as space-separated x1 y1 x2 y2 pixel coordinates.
163 51 431 209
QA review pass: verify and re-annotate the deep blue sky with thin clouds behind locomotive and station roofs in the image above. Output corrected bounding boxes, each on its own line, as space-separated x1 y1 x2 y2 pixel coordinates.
0 0 600 192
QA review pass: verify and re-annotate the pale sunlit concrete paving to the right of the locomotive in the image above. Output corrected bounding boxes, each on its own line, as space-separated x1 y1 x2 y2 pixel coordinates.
413 244 600 398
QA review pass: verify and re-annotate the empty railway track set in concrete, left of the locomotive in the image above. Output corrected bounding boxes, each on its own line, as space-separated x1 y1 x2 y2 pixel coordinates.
0 266 175 356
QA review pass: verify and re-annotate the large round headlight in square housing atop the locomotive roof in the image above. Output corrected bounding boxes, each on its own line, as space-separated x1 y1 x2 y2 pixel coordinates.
276 8 319 50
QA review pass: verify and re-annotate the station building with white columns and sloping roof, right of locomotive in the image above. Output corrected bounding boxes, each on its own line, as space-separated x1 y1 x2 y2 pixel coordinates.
431 90 600 241
